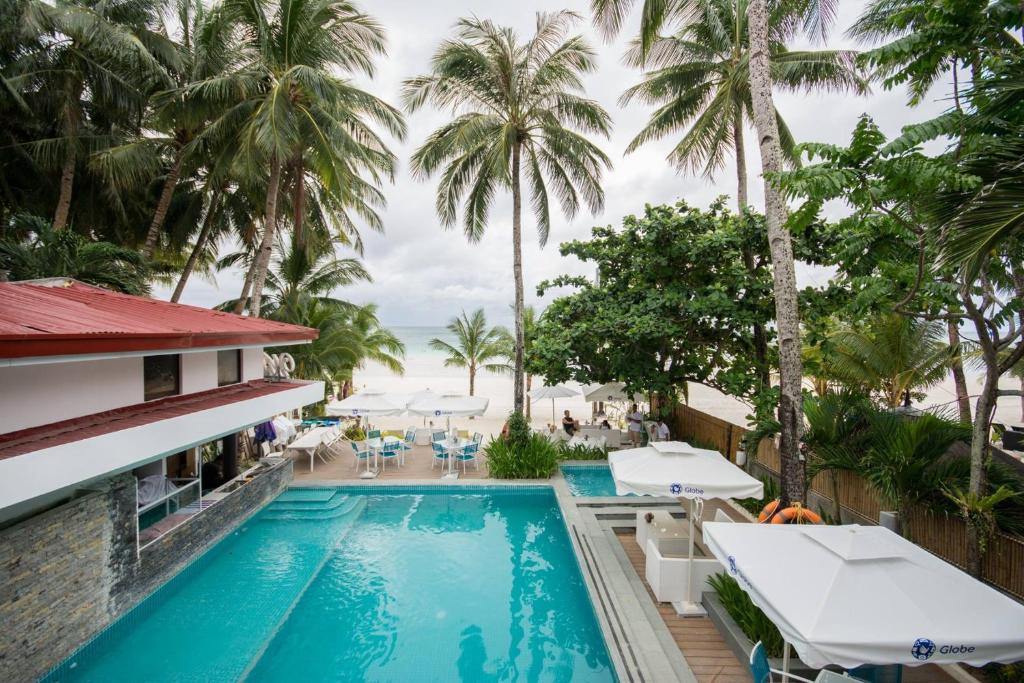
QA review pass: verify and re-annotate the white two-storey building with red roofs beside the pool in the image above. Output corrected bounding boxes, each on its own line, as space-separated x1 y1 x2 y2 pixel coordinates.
0 279 324 523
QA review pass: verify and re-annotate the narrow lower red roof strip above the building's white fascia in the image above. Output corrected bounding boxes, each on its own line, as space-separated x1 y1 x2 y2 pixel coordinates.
0 380 308 460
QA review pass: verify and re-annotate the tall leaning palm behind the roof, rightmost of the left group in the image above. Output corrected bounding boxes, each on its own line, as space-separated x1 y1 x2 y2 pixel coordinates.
203 0 406 315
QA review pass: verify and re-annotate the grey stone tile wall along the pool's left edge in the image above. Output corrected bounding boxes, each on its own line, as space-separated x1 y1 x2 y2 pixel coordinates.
0 461 292 682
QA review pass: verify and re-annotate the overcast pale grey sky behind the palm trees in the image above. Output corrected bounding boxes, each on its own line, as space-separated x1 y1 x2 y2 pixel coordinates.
157 0 947 326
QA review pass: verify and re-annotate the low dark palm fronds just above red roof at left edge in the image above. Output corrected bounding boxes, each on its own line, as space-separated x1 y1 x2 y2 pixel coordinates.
0 217 150 295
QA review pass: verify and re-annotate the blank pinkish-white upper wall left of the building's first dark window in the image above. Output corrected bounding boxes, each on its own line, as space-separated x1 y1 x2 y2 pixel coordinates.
0 356 144 434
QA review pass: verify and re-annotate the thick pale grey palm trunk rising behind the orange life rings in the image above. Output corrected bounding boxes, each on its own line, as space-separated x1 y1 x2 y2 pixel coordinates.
748 0 804 503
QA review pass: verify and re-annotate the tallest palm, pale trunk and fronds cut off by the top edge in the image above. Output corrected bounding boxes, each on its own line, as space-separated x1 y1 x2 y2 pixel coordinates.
591 0 836 503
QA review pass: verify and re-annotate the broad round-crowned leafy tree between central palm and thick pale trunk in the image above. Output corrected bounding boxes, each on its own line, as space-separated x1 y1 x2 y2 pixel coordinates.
530 200 822 399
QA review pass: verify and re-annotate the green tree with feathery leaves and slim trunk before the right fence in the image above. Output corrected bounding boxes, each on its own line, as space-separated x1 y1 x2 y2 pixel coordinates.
778 113 1024 577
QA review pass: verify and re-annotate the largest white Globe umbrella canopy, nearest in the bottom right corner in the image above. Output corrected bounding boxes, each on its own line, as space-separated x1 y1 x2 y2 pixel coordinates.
703 522 1024 669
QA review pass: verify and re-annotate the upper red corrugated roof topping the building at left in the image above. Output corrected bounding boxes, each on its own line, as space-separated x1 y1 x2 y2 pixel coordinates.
0 280 317 358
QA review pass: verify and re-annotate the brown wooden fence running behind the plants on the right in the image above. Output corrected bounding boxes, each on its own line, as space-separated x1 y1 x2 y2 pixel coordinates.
672 405 1024 598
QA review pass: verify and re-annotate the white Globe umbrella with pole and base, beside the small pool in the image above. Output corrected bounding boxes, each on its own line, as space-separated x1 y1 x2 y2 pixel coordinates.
608 441 764 614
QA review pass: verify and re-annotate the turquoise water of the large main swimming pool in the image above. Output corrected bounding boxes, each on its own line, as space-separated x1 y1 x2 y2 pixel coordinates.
46 487 615 683
